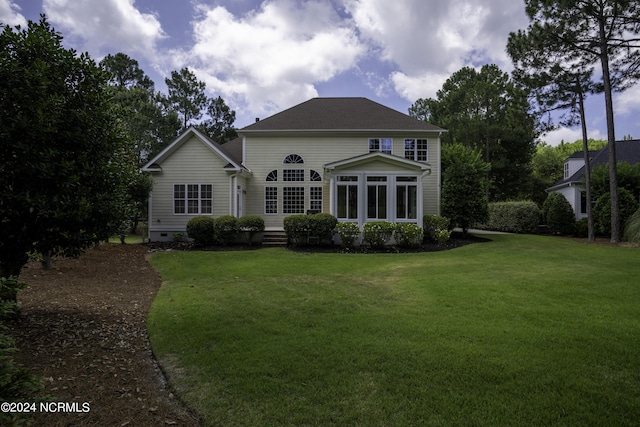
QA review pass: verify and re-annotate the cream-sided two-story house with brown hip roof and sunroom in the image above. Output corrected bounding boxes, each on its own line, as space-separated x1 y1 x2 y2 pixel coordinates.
143 98 445 241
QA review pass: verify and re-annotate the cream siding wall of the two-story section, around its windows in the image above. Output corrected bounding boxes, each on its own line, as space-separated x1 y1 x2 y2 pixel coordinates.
244 132 440 230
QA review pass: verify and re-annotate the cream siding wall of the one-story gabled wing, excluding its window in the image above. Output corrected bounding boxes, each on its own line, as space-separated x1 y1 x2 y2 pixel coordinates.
149 137 232 241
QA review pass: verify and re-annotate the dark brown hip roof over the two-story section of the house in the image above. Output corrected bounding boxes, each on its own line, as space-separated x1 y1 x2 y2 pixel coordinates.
239 98 446 133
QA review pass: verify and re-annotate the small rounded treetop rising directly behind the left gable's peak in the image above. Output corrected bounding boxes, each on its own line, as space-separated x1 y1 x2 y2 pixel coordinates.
165 68 207 129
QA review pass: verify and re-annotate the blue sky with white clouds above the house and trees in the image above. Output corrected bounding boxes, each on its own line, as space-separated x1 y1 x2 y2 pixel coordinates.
0 0 640 145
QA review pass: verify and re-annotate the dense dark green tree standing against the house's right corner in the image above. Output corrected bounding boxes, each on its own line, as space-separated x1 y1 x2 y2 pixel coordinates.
442 143 491 234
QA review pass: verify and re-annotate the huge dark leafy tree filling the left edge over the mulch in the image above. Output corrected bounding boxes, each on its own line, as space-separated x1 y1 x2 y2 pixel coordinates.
0 16 136 277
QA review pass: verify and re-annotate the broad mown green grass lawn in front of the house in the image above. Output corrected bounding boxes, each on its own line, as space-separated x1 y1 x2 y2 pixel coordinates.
148 235 640 426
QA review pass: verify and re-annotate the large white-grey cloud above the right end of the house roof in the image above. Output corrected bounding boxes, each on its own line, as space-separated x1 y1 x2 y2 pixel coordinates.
345 0 527 101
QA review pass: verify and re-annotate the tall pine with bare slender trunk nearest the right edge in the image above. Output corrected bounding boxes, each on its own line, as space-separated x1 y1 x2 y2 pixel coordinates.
525 0 640 243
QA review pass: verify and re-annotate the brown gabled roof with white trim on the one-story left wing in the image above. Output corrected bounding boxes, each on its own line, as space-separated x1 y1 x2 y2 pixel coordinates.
142 127 248 172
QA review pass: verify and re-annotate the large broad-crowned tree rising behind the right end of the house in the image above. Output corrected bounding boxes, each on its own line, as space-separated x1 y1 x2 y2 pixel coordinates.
409 65 536 201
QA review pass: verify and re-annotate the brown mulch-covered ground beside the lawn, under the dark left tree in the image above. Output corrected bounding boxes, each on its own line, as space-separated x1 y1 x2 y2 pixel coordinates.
10 244 200 427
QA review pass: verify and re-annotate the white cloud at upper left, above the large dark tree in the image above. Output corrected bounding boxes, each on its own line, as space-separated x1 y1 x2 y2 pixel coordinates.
43 0 164 60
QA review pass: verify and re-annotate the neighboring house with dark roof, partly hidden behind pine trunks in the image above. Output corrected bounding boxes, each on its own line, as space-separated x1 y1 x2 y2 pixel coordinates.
546 139 640 220
